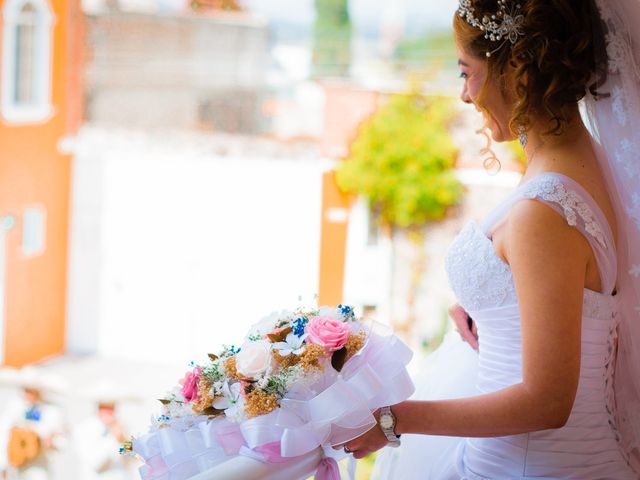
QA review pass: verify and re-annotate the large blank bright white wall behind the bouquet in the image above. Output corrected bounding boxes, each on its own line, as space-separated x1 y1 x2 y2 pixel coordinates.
68 130 325 362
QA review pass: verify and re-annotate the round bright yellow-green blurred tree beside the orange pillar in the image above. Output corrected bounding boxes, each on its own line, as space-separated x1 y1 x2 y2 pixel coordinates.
337 89 463 230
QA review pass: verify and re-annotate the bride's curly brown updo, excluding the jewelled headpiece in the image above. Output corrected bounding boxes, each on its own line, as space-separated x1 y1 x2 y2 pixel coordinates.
453 0 606 135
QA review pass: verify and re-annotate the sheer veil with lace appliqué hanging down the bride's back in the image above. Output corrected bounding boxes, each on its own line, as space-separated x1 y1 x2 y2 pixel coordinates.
583 0 640 476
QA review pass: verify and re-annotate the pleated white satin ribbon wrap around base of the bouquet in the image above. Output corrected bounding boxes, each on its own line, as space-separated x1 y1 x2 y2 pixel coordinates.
133 332 414 480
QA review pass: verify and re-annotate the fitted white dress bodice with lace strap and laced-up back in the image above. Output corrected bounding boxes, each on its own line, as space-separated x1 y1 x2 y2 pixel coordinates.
445 173 634 480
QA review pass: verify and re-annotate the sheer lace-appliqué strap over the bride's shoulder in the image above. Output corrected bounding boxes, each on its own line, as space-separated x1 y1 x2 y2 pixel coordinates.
483 172 617 294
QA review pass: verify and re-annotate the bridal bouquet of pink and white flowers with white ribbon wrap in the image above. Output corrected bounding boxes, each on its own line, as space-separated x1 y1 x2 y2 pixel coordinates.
121 305 413 480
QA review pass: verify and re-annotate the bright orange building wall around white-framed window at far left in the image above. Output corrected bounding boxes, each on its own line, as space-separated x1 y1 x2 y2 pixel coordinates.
0 0 81 366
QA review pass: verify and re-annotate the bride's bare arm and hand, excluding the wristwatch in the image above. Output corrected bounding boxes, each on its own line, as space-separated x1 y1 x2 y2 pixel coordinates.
348 200 591 460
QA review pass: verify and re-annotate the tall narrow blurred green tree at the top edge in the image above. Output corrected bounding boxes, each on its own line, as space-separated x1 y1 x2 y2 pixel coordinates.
313 0 351 78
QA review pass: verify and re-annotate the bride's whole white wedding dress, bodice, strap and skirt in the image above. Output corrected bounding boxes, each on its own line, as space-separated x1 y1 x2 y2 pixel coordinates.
377 172 640 480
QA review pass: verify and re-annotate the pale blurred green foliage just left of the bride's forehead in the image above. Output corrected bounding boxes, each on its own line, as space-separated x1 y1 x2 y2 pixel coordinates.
393 30 457 68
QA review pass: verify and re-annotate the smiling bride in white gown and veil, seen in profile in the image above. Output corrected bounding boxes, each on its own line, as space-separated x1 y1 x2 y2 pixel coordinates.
344 0 640 480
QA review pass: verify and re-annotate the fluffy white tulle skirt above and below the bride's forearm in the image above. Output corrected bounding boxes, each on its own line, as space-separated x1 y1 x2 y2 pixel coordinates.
373 332 480 480
